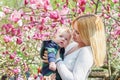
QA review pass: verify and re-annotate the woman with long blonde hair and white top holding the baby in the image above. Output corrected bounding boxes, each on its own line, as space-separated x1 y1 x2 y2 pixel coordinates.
43 14 106 80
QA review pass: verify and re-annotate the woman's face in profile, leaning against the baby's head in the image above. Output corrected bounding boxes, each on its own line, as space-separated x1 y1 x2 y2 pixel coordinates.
73 23 82 43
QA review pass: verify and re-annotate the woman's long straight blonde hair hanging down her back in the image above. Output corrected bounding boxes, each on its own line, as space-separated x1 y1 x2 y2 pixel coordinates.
72 14 106 66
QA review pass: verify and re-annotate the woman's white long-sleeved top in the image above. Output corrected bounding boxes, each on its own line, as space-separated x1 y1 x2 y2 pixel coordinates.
57 42 93 80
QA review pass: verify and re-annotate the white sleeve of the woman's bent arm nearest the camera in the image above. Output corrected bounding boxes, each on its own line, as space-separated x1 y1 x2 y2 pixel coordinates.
57 48 93 80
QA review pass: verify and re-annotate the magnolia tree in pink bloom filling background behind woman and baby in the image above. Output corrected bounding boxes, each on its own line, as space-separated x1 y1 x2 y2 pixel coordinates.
0 0 120 79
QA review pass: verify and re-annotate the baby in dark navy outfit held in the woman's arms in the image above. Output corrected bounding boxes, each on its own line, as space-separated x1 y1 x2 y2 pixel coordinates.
40 27 71 76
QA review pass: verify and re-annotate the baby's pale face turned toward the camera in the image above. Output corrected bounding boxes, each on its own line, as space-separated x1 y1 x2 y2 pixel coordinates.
55 32 71 47
